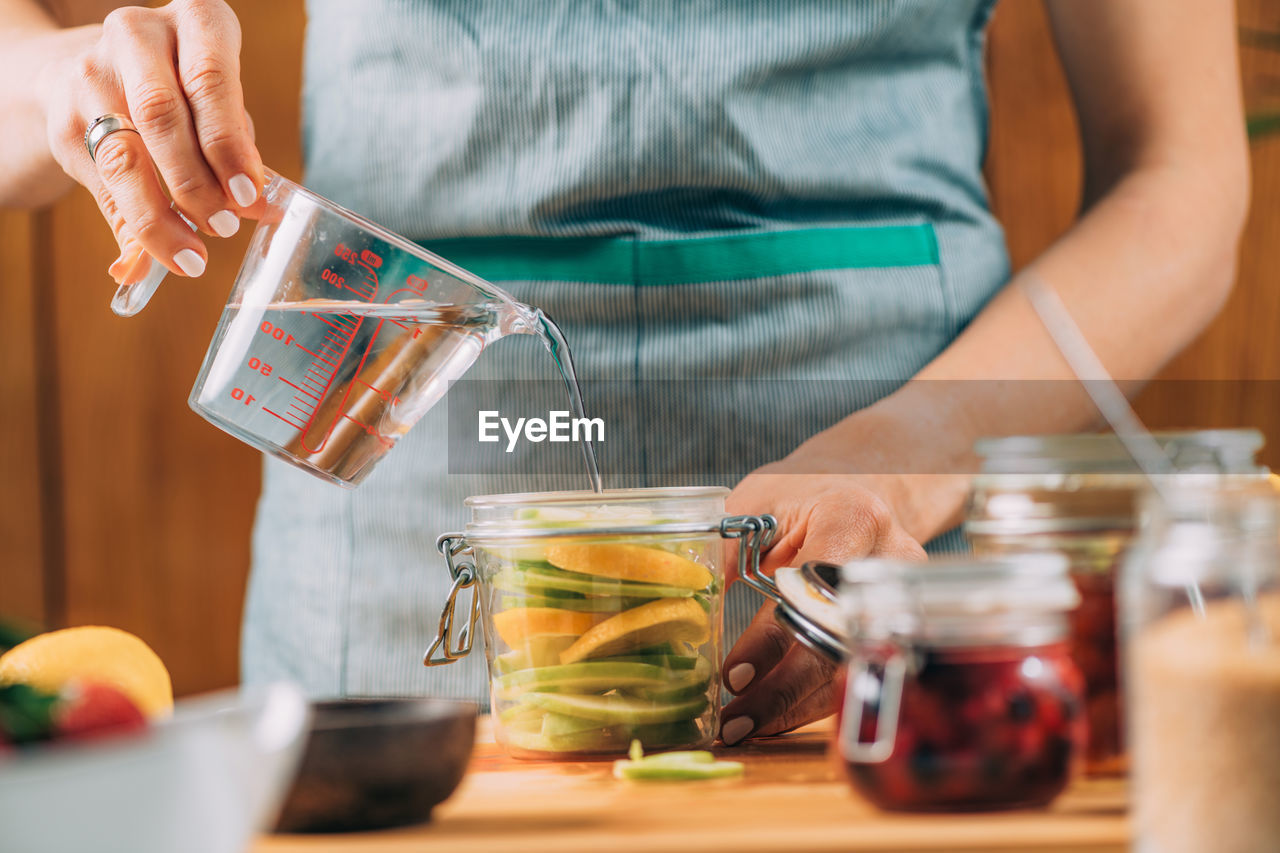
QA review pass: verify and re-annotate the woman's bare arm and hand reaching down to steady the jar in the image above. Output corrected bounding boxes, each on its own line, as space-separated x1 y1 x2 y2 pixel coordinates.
724 0 1248 740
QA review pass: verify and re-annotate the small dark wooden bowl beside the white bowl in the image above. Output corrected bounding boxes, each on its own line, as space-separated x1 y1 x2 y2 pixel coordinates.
275 698 476 833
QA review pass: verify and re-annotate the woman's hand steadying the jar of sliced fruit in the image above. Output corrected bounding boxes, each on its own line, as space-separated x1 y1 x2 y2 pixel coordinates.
721 402 968 745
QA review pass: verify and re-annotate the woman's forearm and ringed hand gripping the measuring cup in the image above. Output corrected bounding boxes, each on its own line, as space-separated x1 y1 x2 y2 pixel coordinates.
0 0 262 275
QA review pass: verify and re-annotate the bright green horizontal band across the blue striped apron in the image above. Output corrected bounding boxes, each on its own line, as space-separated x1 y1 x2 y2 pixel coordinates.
422 223 938 286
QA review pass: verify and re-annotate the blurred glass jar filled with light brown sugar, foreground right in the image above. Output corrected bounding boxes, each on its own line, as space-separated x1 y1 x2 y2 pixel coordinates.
1121 482 1280 853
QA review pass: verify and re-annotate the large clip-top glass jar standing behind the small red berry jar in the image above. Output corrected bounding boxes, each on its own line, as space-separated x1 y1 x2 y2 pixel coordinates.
965 429 1266 775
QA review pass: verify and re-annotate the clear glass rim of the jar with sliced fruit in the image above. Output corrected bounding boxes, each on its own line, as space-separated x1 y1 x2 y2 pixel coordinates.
465 485 728 539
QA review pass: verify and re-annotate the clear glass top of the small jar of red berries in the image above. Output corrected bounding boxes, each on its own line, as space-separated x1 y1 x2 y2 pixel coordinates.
840 552 1080 643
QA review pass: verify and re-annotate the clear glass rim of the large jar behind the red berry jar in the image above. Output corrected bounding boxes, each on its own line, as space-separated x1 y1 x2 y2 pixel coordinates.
974 429 1265 473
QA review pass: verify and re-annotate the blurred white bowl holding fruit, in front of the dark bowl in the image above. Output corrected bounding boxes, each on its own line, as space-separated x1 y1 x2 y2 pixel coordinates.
0 684 310 853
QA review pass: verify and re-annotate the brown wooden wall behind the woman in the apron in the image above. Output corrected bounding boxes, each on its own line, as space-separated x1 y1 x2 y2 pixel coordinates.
0 0 1280 693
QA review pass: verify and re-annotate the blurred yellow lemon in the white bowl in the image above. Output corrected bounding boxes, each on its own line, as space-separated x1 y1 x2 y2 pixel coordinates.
0 625 173 717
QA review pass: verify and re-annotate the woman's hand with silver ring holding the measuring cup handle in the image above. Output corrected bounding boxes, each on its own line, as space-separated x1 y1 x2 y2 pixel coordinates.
40 0 262 277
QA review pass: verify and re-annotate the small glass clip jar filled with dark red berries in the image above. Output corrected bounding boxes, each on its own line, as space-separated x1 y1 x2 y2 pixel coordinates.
838 555 1087 811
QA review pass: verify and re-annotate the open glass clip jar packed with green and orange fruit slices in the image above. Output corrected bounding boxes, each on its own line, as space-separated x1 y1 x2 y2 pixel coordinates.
426 488 773 757
